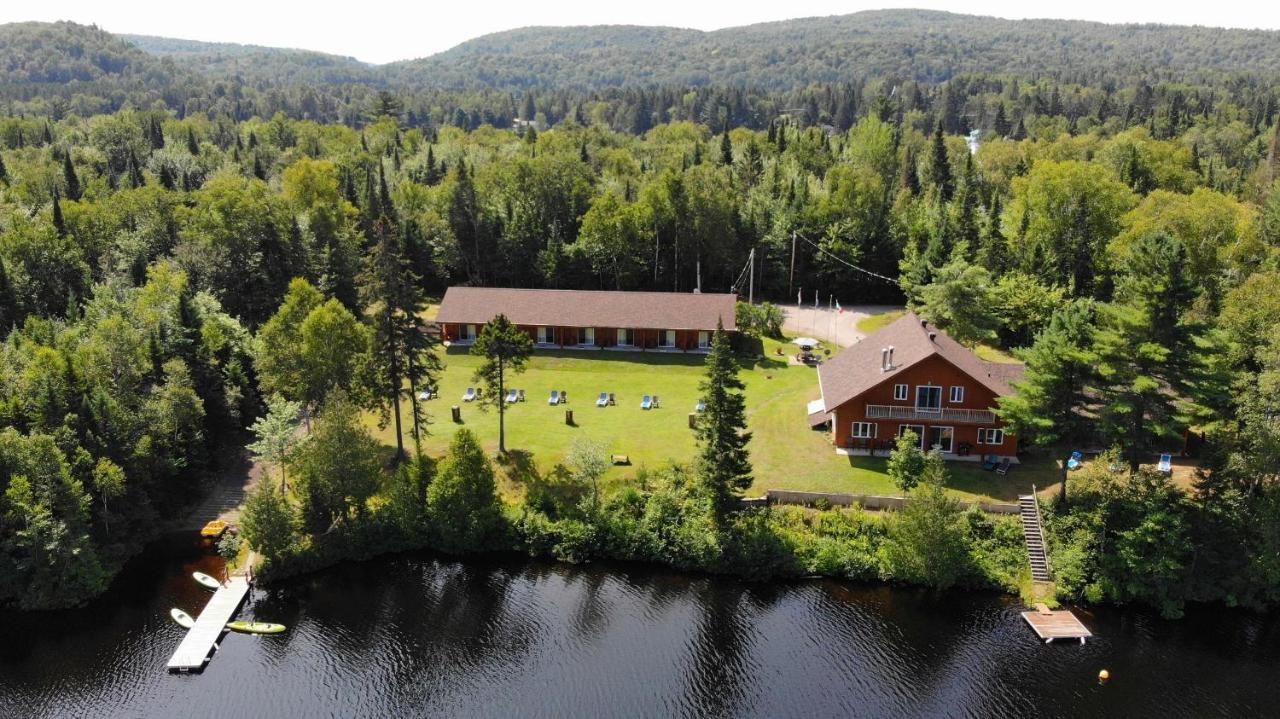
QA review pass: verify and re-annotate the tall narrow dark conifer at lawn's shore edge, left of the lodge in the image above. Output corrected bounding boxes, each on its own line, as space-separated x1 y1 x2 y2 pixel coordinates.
696 322 751 523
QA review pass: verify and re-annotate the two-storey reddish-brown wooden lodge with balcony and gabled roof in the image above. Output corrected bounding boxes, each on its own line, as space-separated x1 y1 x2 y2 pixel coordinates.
808 312 1023 463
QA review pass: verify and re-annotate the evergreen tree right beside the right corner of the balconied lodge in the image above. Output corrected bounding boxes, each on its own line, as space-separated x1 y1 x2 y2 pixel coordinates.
998 299 1094 502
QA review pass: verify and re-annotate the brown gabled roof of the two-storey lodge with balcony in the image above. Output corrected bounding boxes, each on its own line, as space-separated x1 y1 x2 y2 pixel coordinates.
818 312 1023 411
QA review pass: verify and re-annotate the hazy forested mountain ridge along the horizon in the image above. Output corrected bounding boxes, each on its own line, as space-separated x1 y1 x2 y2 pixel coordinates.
0 10 1280 91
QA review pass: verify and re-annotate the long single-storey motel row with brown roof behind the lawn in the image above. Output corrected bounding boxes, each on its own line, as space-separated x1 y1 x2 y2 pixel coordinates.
435 287 737 352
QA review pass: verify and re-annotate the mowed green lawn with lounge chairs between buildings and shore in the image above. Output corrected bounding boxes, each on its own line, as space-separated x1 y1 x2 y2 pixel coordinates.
369 330 1053 500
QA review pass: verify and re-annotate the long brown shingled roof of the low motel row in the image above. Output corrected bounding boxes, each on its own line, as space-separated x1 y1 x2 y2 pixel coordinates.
435 287 737 330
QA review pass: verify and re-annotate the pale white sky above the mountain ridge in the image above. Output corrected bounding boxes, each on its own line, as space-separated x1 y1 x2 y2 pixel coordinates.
0 0 1280 63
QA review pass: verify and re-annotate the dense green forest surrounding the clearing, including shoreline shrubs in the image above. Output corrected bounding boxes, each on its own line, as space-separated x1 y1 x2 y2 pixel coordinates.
0 14 1280 614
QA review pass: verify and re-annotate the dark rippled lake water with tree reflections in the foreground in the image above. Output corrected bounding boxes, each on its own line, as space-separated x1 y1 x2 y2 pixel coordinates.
0 540 1280 719
